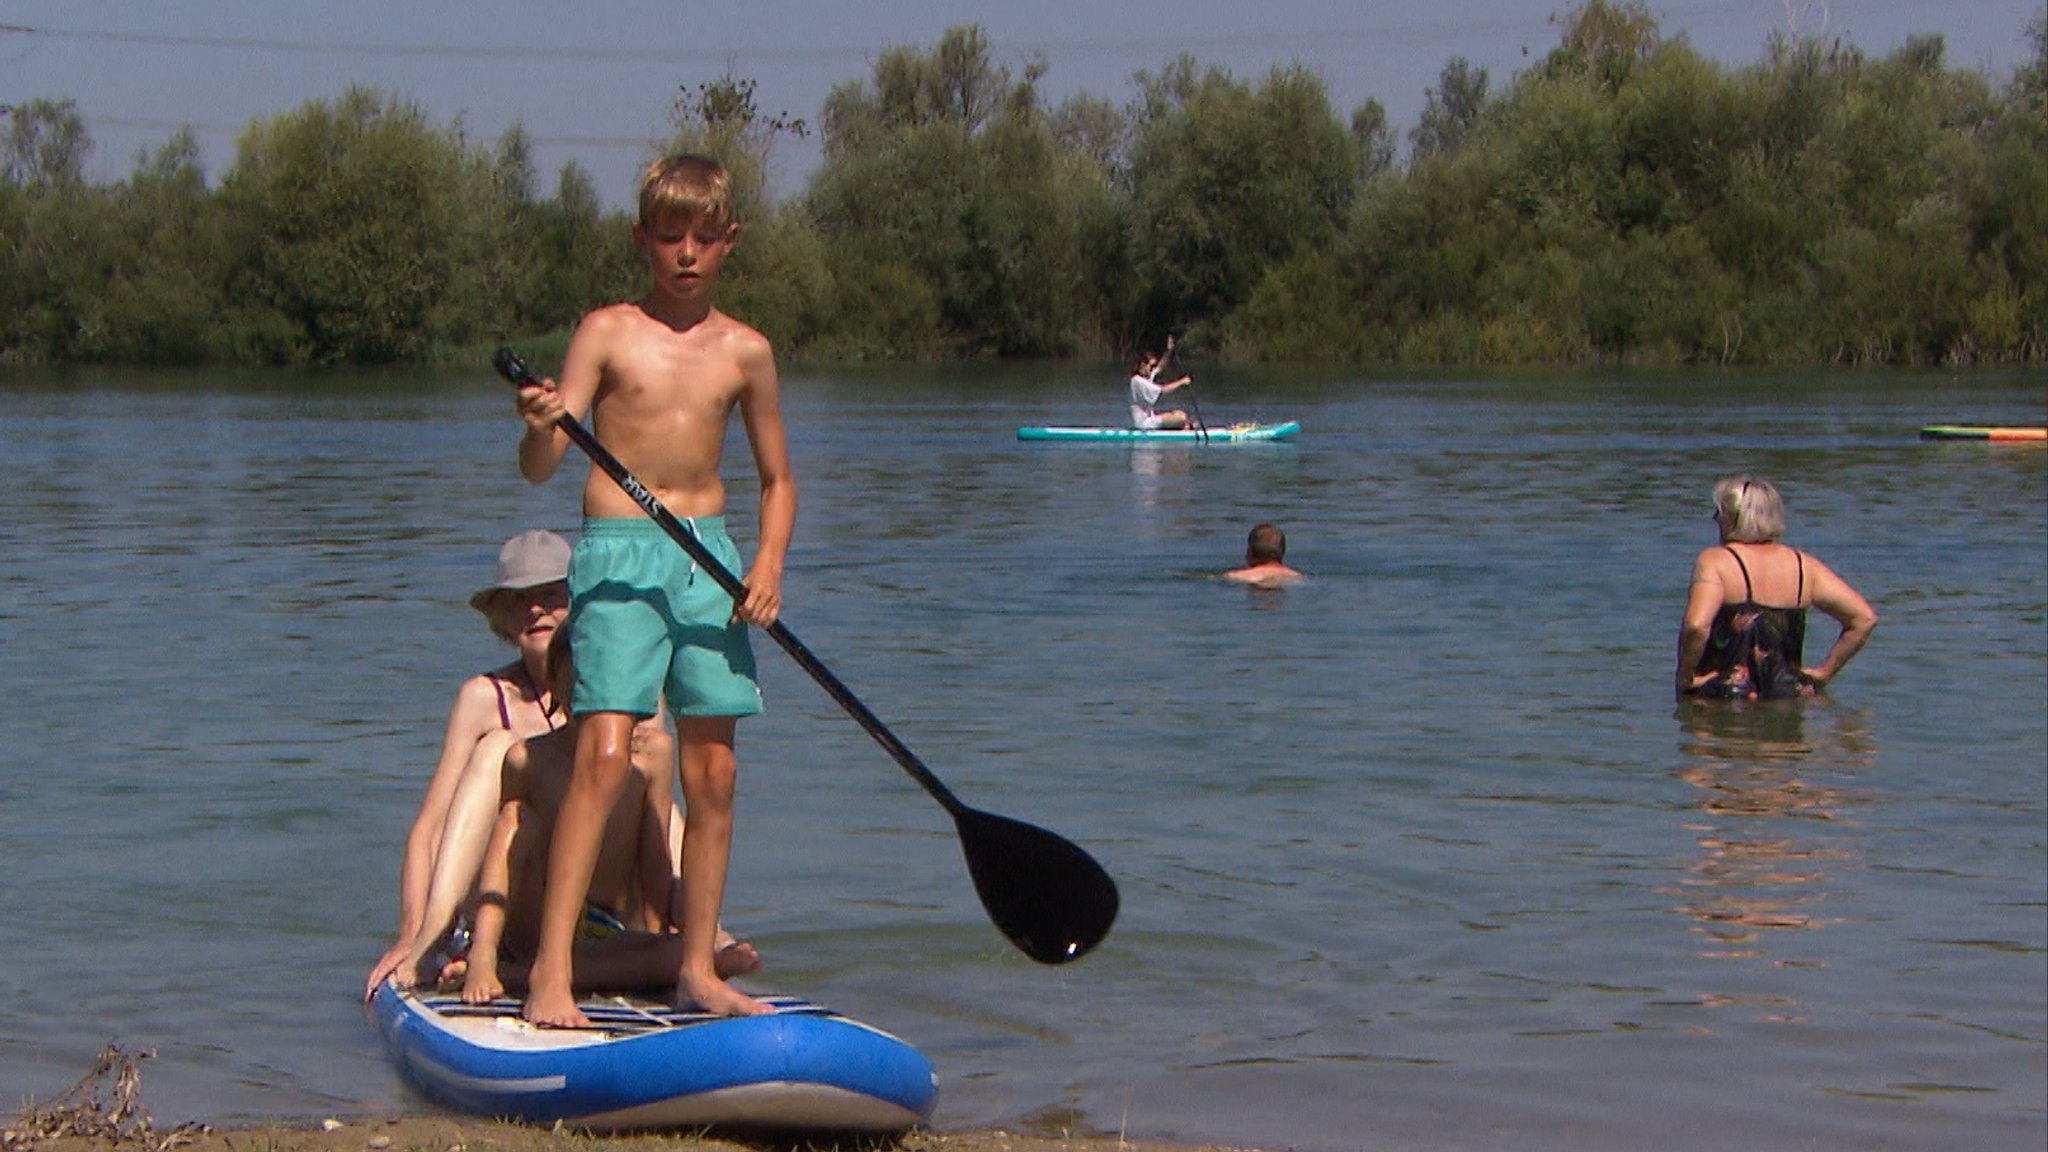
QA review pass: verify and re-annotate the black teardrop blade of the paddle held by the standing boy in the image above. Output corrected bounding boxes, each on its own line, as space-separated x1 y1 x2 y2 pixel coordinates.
954 808 1116 963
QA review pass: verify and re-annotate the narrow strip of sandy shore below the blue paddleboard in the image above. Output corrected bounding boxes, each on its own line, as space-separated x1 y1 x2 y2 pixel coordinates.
4 1117 1245 1152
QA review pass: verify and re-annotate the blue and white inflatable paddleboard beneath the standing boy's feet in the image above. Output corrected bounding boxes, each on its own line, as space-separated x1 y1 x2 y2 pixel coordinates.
371 984 938 1132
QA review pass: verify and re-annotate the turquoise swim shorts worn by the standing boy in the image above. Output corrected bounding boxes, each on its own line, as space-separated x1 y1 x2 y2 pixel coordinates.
569 517 762 715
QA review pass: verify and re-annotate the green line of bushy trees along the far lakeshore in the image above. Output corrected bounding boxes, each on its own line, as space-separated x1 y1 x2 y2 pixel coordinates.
0 0 2048 365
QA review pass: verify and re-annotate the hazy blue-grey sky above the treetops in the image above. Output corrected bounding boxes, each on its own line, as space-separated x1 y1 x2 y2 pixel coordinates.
0 0 2048 207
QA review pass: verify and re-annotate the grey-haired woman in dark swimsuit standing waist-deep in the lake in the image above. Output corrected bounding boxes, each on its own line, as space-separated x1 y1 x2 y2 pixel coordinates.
1675 476 1878 699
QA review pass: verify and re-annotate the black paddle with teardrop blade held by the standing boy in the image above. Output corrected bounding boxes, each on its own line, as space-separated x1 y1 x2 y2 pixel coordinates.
492 348 1116 963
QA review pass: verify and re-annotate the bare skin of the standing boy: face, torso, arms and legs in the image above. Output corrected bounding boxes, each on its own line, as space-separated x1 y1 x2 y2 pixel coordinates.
518 192 797 1027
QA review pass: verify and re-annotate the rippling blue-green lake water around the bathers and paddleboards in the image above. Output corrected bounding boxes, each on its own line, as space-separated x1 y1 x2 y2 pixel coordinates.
0 365 2048 1152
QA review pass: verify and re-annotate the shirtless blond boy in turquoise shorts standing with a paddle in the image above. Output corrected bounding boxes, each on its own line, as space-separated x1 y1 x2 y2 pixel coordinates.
518 156 797 1027
